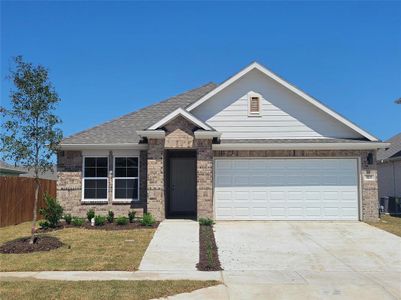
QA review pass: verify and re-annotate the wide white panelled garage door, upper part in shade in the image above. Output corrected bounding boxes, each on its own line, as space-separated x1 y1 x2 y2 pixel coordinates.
214 159 358 220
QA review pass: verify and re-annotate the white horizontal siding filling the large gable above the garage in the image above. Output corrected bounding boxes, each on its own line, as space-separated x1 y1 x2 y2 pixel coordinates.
191 70 361 139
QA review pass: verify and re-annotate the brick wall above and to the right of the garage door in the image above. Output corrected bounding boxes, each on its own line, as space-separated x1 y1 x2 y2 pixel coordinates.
213 150 379 221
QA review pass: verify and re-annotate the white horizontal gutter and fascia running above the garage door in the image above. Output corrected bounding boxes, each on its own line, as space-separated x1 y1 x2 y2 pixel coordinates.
212 142 390 150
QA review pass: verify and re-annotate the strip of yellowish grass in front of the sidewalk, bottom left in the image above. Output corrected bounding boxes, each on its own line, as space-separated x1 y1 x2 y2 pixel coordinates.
0 280 219 300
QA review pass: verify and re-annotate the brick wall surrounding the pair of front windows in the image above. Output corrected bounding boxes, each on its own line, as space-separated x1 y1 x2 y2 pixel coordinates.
57 151 147 217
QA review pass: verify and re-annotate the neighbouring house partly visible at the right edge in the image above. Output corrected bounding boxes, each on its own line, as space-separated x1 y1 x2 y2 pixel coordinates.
377 133 401 197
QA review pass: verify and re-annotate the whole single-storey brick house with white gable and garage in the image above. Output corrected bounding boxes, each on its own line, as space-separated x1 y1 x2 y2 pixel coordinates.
57 63 387 220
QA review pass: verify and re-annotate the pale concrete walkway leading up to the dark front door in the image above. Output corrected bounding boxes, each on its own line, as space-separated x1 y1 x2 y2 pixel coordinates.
139 220 199 271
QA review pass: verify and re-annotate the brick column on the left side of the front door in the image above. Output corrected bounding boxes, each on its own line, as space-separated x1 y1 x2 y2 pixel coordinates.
147 139 165 221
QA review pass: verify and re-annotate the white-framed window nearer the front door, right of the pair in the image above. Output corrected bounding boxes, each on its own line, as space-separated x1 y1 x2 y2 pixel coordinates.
113 157 139 201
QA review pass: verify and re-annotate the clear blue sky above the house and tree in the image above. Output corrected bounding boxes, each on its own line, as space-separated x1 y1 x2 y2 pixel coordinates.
1 1 401 139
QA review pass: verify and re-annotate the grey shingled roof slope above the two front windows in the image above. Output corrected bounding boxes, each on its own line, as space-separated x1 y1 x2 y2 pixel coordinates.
61 82 216 146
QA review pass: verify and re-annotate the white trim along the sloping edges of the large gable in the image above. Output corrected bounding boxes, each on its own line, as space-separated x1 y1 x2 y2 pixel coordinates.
187 62 378 141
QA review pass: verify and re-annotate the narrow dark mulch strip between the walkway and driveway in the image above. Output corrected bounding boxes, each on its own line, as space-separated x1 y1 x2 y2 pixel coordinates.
196 225 223 271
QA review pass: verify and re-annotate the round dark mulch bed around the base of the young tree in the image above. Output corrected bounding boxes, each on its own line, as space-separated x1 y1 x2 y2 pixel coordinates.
0 235 64 254
